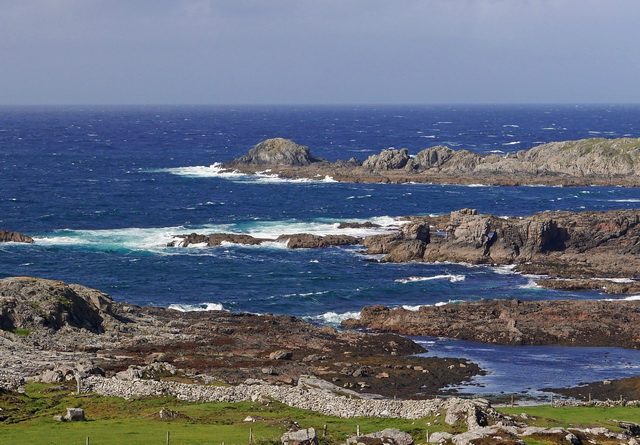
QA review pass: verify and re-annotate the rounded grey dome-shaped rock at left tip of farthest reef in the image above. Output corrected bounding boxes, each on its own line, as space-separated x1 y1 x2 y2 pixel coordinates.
228 138 323 167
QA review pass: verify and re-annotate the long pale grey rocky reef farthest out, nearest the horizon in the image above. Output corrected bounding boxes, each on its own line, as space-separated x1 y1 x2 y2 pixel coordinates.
224 134 640 187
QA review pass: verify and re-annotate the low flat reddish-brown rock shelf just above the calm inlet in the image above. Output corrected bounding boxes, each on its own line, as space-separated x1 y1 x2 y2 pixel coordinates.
343 300 640 349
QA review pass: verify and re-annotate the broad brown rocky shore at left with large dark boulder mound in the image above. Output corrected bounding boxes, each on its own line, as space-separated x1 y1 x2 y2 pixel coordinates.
0 277 480 398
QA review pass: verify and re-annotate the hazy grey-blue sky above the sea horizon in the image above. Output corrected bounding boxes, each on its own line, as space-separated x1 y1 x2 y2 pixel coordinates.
0 0 640 105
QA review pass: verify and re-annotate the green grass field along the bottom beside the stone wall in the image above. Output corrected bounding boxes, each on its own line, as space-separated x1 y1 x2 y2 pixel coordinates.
0 384 640 445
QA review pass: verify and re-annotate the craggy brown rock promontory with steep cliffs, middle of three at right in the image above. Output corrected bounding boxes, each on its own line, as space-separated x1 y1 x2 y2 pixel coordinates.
363 209 640 280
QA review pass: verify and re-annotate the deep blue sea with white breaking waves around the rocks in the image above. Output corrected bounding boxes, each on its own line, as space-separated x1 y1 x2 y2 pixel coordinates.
0 105 640 392
